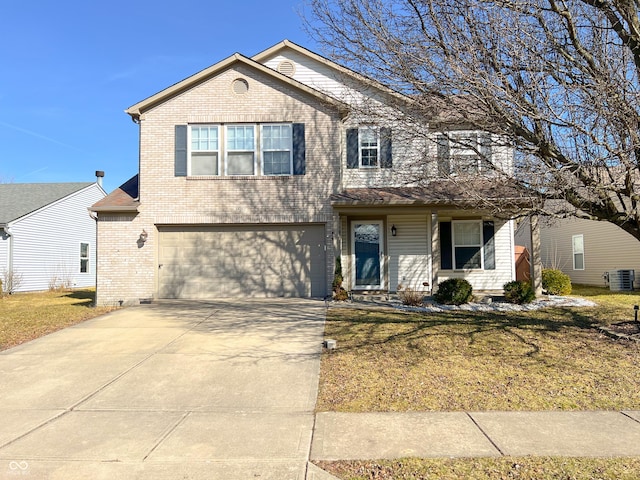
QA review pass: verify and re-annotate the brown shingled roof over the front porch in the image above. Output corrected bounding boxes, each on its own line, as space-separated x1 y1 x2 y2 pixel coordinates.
331 179 532 207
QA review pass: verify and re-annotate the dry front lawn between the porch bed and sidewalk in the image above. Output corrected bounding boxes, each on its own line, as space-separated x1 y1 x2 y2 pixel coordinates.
317 287 640 412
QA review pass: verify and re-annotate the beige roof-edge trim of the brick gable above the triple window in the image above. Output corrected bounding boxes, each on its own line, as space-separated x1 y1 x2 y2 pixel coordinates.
125 48 347 120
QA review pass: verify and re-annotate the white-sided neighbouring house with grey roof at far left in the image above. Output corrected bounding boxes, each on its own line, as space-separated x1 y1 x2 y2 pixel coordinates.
0 182 106 292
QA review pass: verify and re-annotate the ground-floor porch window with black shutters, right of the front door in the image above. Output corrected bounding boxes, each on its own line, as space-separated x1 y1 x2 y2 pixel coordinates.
440 220 496 270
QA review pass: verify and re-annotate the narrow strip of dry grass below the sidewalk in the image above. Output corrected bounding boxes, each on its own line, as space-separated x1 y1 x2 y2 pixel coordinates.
317 457 640 480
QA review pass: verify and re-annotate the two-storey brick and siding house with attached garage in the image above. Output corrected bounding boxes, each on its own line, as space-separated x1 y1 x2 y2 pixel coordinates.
93 41 528 304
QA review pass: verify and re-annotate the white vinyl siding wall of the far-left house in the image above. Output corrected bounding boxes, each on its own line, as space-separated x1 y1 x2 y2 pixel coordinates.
11 184 104 291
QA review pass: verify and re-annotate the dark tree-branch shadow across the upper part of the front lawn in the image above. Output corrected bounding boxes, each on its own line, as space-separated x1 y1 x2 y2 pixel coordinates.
326 307 599 356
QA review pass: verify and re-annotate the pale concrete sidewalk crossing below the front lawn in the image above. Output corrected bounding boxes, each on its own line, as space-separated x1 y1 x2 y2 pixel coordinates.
310 411 640 460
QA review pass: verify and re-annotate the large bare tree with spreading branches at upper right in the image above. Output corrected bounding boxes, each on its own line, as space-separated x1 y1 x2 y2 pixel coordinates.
307 0 640 240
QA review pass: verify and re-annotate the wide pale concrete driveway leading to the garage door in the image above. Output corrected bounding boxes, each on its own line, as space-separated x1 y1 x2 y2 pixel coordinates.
0 299 325 480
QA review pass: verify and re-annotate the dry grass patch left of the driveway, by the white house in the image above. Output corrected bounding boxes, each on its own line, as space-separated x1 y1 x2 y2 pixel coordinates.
0 290 113 350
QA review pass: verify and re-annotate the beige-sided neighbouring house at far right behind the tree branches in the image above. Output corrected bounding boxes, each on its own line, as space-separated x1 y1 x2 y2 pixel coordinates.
540 218 640 288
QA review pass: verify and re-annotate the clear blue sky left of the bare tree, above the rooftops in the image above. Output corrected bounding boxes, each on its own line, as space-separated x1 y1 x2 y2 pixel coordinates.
0 0 320 192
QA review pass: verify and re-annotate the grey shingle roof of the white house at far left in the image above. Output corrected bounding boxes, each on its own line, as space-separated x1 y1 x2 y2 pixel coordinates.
0 182 94 225
